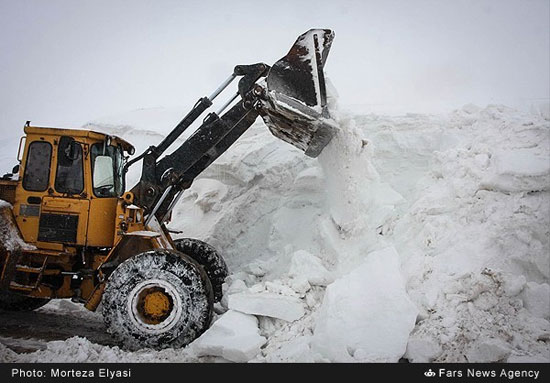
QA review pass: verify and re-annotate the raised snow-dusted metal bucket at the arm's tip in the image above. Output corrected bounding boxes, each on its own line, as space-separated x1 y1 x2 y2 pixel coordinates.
261 29 336 157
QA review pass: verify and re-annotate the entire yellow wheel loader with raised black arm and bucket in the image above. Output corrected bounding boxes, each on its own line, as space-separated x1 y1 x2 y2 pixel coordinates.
0 29 336 349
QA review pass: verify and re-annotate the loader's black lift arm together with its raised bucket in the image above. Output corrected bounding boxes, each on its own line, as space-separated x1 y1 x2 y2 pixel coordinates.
126 29 335 223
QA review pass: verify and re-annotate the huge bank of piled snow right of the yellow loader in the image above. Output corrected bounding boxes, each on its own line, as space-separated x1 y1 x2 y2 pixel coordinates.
179 105 550 362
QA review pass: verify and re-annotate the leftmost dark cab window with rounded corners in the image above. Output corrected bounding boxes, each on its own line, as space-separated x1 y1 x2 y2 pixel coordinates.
23 141 52 191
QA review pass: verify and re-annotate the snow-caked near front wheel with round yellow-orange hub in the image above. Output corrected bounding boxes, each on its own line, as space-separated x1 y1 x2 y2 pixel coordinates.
103 249 213 350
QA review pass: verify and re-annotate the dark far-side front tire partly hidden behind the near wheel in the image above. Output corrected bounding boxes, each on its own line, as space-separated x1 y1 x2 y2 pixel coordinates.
174 238 229 302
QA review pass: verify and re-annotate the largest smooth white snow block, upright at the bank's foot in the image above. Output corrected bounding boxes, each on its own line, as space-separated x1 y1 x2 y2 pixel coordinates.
311 247 418 362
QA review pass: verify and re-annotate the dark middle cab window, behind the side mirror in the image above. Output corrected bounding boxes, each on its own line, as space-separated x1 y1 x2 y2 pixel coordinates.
55 137 84 194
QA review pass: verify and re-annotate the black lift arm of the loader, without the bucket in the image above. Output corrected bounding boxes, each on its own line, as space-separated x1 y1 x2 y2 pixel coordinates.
132 63 270 222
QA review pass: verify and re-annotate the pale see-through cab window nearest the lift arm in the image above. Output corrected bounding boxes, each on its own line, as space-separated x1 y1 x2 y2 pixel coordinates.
91 143 125 198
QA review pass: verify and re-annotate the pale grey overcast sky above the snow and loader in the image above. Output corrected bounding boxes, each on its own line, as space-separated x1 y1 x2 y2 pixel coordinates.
0 0 550 133
